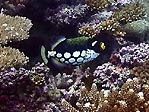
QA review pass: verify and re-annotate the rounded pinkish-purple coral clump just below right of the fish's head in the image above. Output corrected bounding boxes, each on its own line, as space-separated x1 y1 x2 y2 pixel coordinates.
93 63 133 89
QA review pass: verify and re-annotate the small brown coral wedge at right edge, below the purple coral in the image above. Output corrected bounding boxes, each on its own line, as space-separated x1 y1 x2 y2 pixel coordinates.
131 59 149 84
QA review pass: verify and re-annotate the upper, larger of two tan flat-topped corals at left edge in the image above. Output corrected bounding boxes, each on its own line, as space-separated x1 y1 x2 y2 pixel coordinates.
0 14 32 44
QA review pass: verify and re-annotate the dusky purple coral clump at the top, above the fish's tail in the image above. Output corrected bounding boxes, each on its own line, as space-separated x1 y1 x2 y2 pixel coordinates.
47 4 87 25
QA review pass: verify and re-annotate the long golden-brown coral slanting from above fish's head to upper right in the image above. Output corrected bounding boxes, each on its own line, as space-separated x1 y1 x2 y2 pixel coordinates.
79 2 146 37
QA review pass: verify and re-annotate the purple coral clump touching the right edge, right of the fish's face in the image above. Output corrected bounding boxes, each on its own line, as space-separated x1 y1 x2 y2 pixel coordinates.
111 43 149 68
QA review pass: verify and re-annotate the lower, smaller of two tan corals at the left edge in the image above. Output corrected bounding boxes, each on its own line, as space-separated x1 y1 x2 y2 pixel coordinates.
0 47 28 70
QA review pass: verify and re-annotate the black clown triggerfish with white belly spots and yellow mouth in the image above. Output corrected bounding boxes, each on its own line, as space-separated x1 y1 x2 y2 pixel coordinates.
41 36 105 66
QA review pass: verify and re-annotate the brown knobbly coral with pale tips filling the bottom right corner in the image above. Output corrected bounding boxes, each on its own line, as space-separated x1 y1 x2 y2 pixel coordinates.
62 78 149 112
